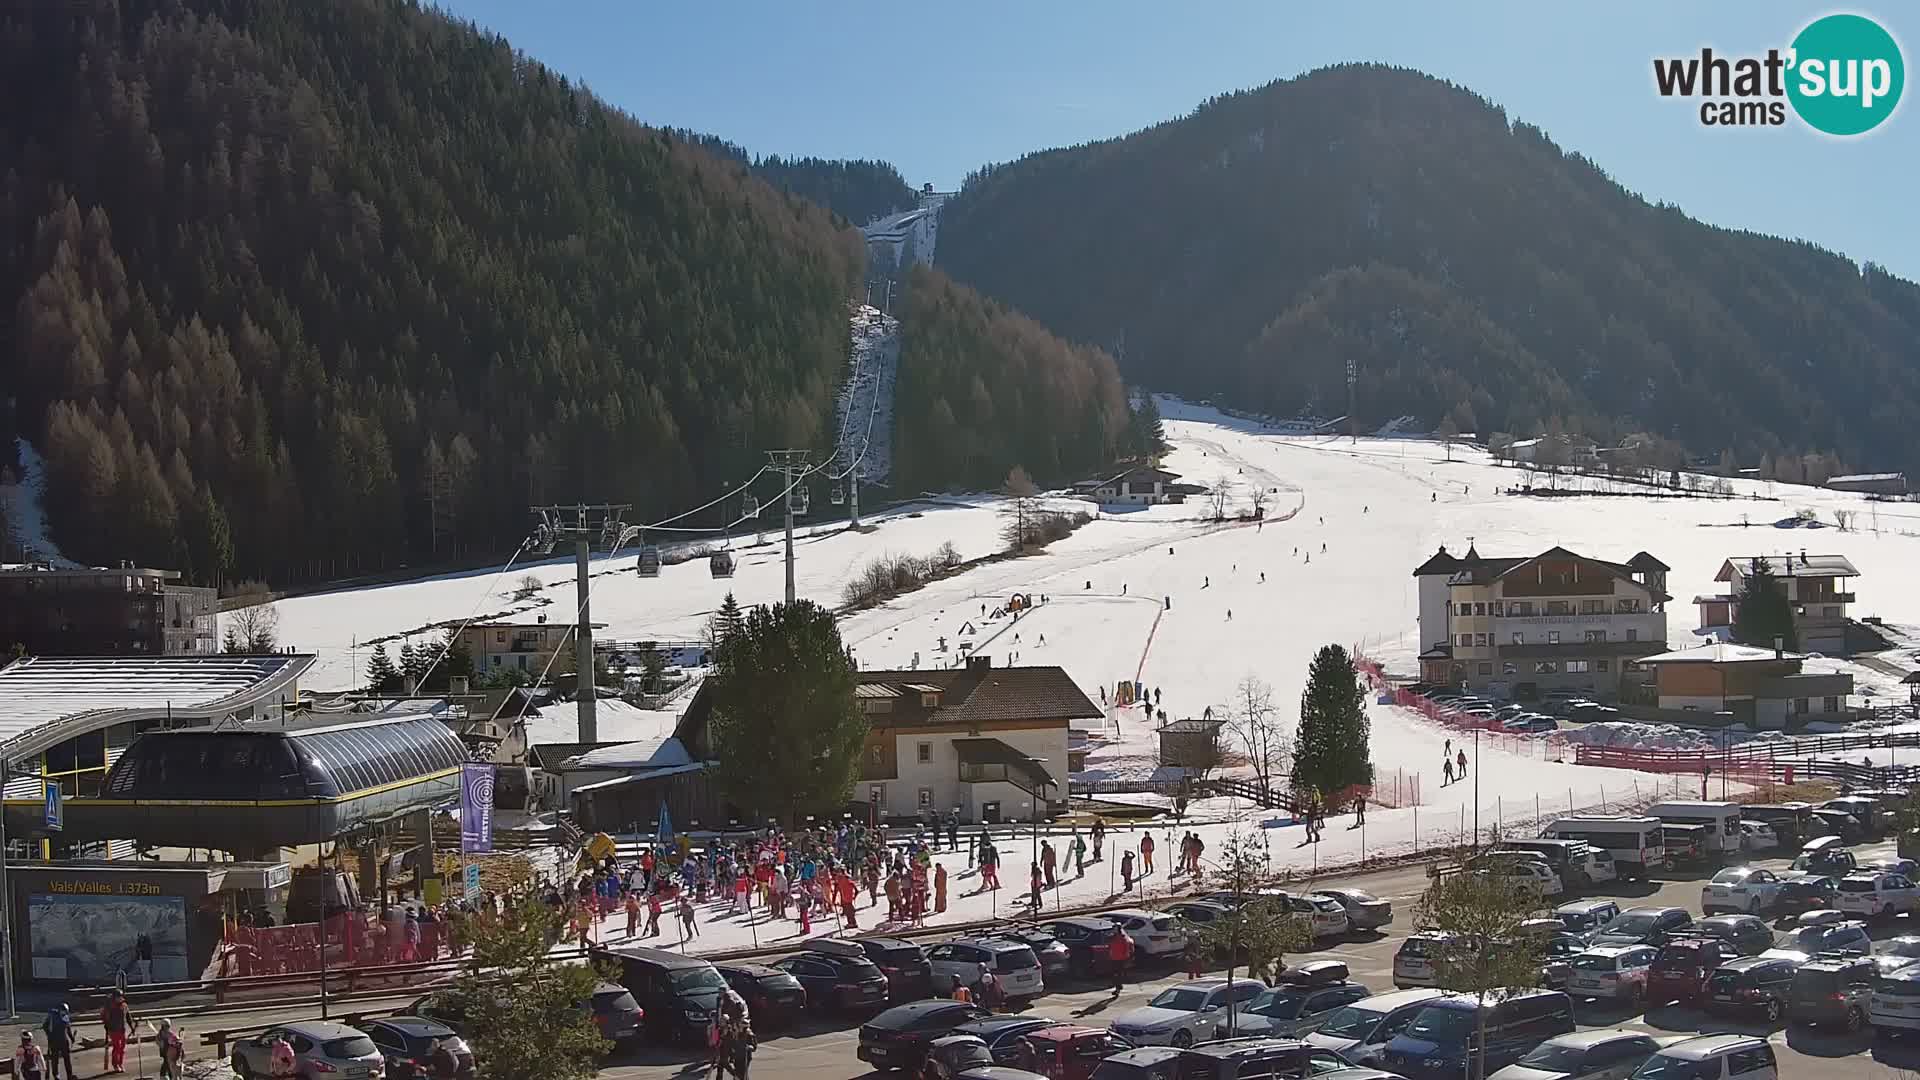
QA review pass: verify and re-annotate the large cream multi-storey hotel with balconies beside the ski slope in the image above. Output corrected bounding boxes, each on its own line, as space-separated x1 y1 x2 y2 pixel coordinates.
1413 544 1672 696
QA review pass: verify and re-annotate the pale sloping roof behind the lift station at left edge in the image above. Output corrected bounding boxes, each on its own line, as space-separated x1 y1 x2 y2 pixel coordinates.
0 653 313 757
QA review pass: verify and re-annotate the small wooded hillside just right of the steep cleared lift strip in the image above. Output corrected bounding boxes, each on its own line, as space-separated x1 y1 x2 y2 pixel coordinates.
893 265 1140 490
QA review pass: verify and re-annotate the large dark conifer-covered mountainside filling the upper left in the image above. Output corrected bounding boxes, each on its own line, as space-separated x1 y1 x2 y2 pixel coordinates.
0 0 864 582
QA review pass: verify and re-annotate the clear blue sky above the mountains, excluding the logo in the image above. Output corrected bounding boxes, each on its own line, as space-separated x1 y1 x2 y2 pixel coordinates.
442 0 1920 279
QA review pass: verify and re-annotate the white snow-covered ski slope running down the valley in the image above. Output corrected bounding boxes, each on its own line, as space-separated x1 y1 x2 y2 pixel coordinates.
266 400 1920 947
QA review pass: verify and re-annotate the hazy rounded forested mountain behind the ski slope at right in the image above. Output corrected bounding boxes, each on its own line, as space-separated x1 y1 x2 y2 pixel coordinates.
939 65 1920 469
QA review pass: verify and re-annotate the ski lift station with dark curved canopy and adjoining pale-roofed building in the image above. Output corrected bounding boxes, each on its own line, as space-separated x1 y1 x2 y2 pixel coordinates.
0 653 487 986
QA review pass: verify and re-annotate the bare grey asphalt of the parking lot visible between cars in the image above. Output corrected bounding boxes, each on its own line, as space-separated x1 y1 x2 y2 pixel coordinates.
603 842 1920 1080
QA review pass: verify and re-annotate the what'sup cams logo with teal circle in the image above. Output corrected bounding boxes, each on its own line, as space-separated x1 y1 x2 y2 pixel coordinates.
1653 13 1907 136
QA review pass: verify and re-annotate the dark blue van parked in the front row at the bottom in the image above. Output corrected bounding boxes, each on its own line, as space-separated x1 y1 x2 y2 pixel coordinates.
1380 990 1574 1080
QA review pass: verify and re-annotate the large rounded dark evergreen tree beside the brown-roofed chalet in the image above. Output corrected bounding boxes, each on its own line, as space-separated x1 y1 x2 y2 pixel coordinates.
710 600 866 821
